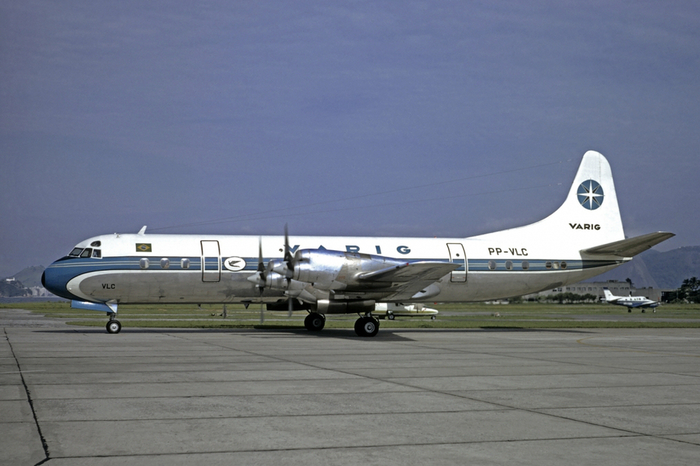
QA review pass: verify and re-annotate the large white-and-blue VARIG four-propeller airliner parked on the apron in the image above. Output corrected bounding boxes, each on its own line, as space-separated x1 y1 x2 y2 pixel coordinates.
42 151 675 337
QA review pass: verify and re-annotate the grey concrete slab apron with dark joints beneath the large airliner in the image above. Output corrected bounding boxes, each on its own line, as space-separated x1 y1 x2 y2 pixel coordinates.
0 309 700 466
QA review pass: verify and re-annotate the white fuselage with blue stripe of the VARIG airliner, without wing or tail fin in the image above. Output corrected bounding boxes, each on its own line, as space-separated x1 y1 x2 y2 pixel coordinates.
43 234 622 304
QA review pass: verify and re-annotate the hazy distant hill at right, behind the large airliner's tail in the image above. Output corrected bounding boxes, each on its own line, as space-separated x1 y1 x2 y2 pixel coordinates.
587 246 700 289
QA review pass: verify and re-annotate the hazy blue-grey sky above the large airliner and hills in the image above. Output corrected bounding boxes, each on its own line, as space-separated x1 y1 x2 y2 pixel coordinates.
0 0 700 277
